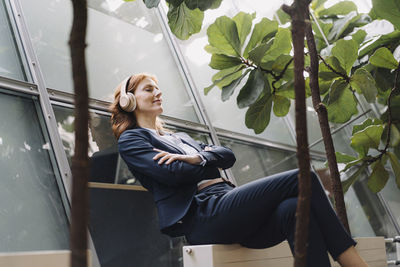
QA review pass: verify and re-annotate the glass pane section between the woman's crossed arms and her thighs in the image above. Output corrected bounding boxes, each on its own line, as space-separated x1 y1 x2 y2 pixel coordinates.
220 137 297 185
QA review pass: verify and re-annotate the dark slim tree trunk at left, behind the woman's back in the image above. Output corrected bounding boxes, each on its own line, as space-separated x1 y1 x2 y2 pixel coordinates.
69 0 89 267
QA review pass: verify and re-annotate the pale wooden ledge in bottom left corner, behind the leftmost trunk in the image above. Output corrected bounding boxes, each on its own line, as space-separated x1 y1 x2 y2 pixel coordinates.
0 250 92 267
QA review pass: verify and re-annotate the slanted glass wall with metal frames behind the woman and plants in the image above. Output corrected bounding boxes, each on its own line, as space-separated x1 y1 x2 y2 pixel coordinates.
0 0 400 267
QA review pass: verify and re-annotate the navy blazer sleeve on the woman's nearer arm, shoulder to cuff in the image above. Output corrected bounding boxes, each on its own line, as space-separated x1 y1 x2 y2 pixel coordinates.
118 131 220 186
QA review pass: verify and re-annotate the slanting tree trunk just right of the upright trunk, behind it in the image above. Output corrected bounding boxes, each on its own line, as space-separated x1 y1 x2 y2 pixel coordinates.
305 7 350 233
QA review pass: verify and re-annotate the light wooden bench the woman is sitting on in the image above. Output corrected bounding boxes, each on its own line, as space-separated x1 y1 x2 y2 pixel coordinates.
183 237 387 267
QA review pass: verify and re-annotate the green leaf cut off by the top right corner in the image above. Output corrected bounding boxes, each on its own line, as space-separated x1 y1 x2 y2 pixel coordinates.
372 0 400 29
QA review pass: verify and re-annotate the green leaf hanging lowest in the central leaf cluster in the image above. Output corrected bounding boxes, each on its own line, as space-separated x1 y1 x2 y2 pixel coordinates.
245 91 272 134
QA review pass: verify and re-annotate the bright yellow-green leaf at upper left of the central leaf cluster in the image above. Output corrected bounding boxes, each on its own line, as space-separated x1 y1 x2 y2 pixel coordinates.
207 16 240 56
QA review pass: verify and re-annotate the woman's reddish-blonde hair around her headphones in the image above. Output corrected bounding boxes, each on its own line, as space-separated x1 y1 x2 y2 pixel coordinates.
109 73 170 139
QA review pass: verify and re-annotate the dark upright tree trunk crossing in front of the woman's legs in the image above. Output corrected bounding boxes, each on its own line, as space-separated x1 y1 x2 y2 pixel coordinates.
282 0 311 267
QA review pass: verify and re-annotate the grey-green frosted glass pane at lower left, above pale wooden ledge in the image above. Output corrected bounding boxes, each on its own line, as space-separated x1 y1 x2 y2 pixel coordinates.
0 93 69 252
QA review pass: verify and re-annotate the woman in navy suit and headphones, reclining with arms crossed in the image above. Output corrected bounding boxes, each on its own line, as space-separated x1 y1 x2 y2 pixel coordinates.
111 74 367 267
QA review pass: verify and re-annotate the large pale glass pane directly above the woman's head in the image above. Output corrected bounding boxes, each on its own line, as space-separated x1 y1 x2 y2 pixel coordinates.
21 0 198 122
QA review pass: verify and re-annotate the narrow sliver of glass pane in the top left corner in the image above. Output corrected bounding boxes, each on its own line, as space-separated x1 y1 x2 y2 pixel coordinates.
0 0 26 80
